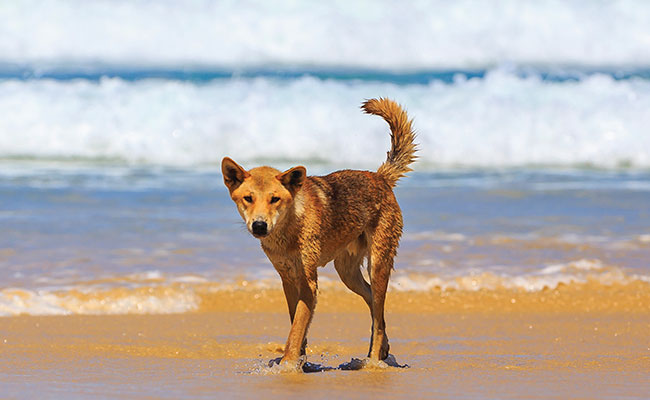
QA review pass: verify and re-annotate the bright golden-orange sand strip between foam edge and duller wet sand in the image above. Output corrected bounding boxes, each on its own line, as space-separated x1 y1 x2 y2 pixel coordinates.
198 280 650 314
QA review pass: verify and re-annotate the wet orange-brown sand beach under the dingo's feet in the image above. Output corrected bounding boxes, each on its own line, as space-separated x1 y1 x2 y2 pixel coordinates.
0 282 650 399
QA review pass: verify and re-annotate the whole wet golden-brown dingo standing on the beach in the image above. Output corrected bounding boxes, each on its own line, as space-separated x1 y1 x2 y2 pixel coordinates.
222 99 416 366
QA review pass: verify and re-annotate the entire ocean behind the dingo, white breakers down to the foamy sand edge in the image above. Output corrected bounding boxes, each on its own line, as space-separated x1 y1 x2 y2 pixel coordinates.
0 0 650 315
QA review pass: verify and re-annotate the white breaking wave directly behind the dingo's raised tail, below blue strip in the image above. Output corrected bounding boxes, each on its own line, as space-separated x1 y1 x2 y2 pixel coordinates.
0 70 650 168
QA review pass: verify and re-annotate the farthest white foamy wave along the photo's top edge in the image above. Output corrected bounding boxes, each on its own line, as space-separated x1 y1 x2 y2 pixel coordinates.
0 0 650 69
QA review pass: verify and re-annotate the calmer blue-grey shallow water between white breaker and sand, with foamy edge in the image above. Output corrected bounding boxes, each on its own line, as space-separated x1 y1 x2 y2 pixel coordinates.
0 161 650 315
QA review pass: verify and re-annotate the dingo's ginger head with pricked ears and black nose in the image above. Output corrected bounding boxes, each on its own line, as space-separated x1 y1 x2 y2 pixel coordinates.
221 157 307 239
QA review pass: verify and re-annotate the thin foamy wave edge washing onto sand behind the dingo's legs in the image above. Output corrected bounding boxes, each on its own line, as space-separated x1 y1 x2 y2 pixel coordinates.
0 260 650 316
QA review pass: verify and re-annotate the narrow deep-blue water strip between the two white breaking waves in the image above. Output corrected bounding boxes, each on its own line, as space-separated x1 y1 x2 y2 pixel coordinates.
5 64 650 85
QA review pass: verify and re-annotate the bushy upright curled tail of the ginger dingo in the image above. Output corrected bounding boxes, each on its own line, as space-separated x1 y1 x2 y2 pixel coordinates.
361 98 417 186
